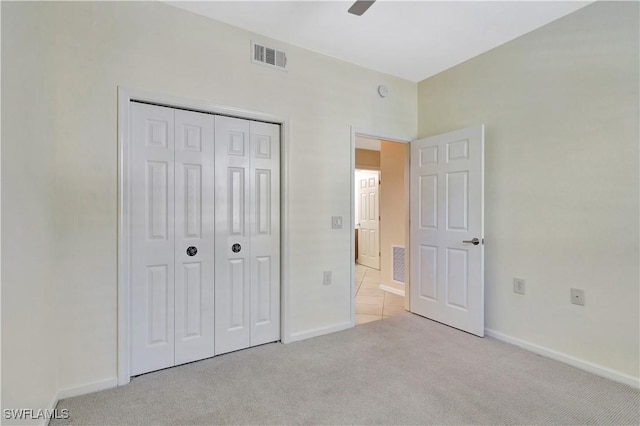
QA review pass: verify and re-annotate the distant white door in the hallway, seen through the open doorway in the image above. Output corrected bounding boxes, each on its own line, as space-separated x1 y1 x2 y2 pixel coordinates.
356 171 380 269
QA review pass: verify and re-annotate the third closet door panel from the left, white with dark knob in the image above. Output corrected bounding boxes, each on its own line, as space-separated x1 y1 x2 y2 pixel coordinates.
215 116 251 355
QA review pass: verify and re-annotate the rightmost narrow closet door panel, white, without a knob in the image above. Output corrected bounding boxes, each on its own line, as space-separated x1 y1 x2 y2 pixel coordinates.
249 121 280 346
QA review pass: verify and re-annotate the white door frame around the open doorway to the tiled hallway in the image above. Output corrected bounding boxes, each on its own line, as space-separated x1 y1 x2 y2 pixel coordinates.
349 125 416 327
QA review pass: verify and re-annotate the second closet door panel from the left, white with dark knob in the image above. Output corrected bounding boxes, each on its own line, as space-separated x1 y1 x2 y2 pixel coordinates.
175 109 215 365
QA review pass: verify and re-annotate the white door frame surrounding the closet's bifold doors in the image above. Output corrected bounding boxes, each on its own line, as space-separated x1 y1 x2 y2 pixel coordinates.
117 86 290 385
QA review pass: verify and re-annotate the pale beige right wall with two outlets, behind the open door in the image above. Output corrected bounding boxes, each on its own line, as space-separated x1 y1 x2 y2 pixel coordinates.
418 2 640 378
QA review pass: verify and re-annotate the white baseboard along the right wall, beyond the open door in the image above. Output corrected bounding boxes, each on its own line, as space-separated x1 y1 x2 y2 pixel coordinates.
484 328 640 389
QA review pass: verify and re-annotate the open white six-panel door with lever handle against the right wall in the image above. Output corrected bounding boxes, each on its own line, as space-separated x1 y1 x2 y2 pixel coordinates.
410 126 484 336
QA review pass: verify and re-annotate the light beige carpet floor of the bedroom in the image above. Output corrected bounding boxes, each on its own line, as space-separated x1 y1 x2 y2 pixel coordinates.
51 313 640 425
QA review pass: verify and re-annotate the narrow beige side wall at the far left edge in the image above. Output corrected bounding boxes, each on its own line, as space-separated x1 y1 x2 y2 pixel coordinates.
0 3 58 424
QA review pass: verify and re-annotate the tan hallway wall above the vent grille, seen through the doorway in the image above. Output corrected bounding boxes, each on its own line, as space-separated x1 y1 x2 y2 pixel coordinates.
380 141 407 288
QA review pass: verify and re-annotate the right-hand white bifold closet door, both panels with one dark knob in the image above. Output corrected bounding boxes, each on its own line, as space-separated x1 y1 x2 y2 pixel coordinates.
215 116 280 354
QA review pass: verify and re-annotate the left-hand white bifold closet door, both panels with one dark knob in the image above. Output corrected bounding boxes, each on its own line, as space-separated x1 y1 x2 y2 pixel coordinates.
129 102 214 375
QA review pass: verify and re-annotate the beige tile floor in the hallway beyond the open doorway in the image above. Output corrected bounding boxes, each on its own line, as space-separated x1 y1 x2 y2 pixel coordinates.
354 264 404 325
